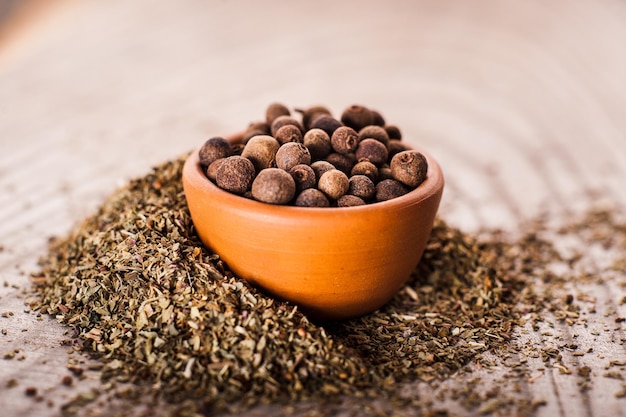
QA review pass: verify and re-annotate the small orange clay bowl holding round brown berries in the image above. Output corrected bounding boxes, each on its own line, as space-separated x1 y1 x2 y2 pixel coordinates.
182 135 444 320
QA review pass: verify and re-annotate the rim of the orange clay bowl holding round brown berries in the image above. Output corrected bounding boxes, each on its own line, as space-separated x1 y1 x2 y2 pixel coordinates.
183 132 444 214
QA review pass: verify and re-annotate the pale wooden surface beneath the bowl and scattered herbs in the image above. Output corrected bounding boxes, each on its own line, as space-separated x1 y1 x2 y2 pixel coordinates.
0 0 626 417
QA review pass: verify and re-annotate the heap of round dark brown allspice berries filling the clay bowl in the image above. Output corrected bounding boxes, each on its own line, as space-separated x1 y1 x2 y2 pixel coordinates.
199 103 428 207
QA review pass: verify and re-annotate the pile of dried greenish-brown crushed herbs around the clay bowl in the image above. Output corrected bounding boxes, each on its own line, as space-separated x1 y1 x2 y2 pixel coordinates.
34 154 624 414
